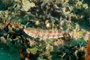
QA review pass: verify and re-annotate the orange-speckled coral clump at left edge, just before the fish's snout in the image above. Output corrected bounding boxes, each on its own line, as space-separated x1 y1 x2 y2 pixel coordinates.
0 19 23 31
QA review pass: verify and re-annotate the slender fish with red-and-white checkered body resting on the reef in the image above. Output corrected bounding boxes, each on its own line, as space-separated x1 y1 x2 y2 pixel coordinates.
24 27 63 38
